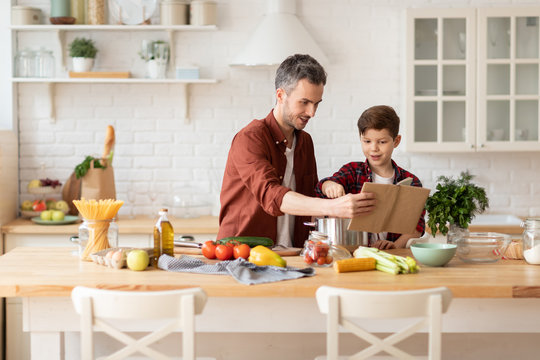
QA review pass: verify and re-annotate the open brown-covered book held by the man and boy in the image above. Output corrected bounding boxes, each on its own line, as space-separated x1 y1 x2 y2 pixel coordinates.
348 182 430 234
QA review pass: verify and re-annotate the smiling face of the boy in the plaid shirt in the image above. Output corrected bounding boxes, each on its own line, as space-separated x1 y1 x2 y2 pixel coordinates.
360 129 401 167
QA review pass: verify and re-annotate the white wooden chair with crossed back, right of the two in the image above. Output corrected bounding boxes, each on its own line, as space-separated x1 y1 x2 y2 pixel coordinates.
316 286 452 360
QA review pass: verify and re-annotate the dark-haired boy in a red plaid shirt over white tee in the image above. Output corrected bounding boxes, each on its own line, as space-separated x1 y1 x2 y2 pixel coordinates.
315 105 426 249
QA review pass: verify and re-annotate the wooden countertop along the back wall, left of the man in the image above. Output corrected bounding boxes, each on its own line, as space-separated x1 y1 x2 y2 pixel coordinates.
2 216 219 235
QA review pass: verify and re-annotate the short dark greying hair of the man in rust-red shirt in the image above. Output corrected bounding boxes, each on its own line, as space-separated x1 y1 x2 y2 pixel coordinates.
276 54 326 93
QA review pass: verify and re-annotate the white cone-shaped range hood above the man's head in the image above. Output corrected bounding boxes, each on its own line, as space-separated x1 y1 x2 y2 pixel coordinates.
231 0 328 66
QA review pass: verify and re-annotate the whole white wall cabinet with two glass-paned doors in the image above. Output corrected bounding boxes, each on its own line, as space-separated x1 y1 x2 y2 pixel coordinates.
406 8 540 152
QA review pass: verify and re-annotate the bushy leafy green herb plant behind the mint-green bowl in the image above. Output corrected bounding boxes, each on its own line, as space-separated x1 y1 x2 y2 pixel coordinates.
426 171 489 243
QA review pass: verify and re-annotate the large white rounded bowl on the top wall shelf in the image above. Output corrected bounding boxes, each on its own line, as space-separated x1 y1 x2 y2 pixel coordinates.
109 0 157 25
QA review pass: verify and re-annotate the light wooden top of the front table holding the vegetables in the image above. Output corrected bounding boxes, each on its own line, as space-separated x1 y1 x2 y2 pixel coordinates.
0 247 540 298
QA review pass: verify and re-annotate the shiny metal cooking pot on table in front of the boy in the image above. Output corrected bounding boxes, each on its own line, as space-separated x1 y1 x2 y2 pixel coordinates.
304 217 368 246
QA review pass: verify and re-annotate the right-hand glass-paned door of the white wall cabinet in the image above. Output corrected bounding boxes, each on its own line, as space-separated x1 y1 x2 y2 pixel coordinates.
477 8 540 151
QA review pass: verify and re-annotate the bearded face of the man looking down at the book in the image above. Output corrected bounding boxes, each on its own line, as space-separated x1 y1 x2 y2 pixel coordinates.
277 79 324 130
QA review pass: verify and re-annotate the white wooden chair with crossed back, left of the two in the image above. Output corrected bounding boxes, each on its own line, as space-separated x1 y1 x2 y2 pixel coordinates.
71 286 206 360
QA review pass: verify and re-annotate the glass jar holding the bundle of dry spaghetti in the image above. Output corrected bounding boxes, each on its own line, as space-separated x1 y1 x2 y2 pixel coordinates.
77 218 118 261
